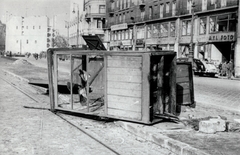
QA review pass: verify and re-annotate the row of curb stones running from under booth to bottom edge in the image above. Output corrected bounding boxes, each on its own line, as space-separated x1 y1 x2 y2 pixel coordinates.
115 121 209 155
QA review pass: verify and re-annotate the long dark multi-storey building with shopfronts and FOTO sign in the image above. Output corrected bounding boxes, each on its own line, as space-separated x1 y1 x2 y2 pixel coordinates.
105 0 240 76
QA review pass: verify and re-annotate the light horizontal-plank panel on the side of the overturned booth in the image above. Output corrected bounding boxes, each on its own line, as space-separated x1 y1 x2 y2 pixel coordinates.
106 56 142 120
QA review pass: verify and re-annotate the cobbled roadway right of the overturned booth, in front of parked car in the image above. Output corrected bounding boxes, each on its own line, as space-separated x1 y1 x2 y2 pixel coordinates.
194 76 240 112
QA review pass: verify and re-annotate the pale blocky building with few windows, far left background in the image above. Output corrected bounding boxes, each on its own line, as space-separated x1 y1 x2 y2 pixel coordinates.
5 16 55 54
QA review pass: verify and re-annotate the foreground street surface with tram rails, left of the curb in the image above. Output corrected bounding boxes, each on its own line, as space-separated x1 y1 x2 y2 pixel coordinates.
0 57 173 155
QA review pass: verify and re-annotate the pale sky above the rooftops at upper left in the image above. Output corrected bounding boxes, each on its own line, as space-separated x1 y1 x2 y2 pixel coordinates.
0 0 71 36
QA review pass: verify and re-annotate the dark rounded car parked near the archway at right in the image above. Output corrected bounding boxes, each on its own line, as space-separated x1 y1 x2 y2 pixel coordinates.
177 58 218 77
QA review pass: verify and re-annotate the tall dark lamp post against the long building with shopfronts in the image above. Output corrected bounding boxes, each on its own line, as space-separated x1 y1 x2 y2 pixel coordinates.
188 0 195 63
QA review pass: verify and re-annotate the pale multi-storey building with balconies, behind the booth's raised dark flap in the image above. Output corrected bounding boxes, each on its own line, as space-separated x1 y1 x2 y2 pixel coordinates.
69 0 106 46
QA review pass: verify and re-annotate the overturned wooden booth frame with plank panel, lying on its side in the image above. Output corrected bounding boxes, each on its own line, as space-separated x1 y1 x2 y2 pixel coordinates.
47 49 176 124
